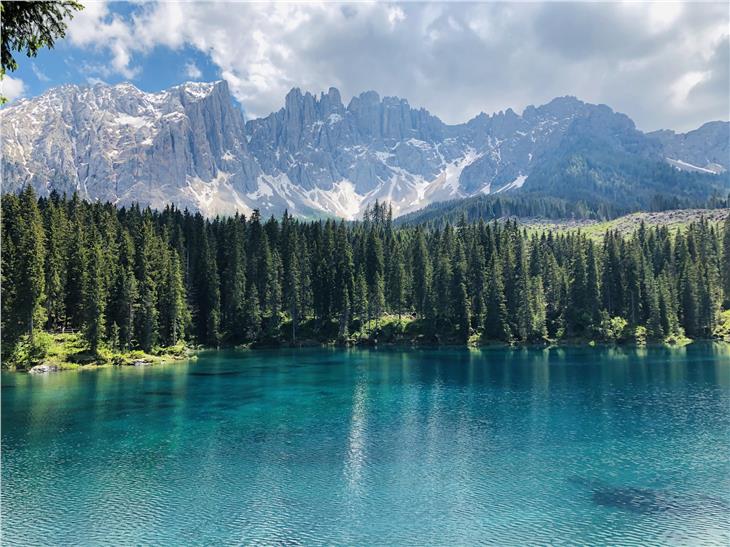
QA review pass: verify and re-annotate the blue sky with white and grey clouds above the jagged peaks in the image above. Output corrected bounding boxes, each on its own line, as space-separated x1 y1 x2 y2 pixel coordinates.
3 0 730 131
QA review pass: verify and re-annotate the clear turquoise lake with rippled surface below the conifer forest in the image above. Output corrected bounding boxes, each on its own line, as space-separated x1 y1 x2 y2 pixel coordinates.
2 344 730 546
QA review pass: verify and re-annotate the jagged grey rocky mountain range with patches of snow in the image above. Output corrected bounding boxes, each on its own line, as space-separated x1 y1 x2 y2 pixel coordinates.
0 81 730 219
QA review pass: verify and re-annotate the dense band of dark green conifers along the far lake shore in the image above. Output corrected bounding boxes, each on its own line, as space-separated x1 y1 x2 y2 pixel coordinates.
2 188 730 363
